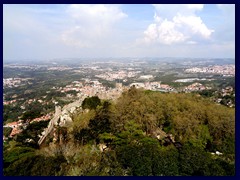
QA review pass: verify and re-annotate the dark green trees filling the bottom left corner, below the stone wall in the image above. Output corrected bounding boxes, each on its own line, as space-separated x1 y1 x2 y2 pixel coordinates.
3 141 66 176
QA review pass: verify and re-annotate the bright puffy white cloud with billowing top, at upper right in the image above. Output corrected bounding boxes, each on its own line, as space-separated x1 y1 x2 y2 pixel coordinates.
144 4 214 45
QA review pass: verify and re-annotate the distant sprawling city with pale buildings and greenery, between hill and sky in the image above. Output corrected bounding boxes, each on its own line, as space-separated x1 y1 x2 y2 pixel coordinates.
3 58 235 135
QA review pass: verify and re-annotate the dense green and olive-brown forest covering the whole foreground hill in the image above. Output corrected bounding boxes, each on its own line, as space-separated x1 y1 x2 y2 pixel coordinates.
4 87 235 176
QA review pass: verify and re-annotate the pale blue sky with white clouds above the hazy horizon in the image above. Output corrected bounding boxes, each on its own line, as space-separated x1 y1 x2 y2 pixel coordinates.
3 4 235 60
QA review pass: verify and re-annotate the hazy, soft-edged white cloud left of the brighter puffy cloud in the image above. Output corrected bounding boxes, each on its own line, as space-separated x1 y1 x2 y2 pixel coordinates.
62 4 127 47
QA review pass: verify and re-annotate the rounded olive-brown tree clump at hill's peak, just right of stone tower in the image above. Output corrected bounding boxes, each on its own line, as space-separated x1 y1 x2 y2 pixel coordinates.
112 87 163 133
